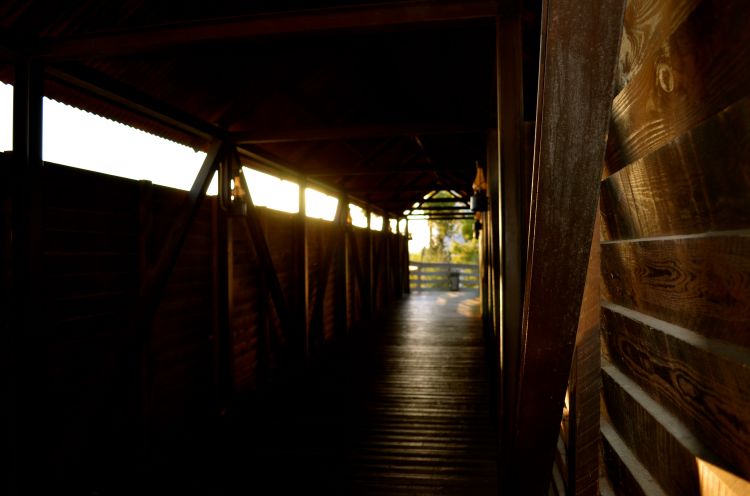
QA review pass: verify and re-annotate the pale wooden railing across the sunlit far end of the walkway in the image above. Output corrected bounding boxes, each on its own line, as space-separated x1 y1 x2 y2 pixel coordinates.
409 260 479 291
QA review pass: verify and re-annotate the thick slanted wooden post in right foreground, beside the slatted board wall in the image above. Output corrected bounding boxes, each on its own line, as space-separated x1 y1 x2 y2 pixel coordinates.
508 0 625 494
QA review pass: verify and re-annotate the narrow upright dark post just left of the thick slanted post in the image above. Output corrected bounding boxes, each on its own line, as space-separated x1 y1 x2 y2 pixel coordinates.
495 4 527 492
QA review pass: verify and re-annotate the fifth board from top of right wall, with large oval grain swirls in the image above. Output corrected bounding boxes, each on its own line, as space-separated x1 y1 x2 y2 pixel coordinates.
602 304 750 478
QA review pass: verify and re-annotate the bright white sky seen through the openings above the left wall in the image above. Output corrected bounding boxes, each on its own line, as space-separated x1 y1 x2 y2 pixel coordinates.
0 83 429 253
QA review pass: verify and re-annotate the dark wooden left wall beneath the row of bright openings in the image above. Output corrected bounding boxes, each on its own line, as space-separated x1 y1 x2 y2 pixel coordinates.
2 161 406 490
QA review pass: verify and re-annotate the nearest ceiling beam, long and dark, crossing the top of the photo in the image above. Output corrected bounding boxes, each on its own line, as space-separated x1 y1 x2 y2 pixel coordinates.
33 0 497 60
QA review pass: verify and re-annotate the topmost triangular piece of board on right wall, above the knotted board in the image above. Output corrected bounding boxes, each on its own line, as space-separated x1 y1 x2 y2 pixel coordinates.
615 0 700 94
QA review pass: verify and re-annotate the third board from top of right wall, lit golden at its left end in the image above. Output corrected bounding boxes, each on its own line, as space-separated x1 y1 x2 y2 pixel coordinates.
601 98 750 240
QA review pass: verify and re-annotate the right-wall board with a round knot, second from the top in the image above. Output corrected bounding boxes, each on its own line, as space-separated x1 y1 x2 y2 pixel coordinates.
607 0 750 174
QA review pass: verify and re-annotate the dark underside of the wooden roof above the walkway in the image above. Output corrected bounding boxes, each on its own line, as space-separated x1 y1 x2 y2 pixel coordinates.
2 0 512 217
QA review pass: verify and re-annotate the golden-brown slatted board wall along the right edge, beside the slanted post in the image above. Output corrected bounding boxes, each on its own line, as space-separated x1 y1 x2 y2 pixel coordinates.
601 0 750 495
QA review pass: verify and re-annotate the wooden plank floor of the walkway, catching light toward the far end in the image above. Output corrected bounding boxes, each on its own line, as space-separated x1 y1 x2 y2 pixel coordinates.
351 292 497 495
